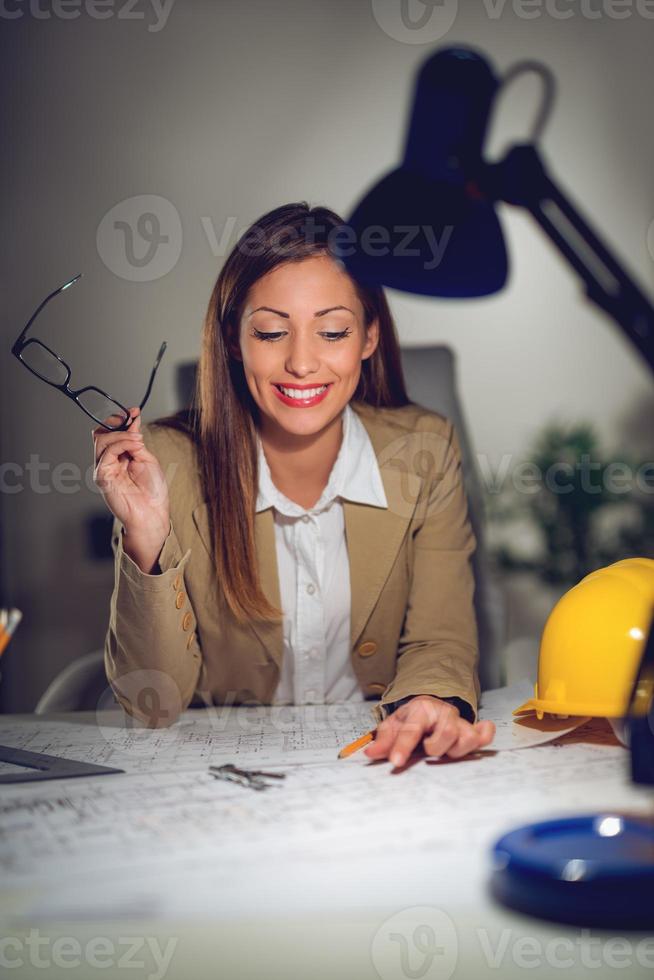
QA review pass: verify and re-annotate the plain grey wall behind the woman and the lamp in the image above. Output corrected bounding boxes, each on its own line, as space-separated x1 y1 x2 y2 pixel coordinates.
0 0 654 711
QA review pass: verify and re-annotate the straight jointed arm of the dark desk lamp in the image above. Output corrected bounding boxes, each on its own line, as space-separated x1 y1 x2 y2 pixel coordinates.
492 144 654 371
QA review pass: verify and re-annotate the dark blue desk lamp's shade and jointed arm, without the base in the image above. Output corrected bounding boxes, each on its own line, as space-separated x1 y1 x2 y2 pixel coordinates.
335 48 654 369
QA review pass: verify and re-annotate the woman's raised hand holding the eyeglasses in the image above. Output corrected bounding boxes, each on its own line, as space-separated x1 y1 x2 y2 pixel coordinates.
93 408 170 572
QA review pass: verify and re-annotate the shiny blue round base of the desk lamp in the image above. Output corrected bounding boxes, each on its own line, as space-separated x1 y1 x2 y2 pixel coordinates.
490 813 654 929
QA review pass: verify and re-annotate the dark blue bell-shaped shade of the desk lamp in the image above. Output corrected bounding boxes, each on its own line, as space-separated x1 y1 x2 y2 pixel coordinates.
335 48 507 298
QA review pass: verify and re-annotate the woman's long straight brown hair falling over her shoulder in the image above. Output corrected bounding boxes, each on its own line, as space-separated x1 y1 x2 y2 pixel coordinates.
159 201 409 623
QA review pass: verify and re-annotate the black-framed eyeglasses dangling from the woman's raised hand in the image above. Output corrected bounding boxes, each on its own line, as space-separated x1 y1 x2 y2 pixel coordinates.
11 272 167 432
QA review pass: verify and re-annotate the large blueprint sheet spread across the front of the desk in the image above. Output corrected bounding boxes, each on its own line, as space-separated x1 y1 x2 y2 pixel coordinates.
0 695 651 921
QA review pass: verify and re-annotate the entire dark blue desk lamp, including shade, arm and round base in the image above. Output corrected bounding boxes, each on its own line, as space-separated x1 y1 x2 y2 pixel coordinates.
334 48 654 928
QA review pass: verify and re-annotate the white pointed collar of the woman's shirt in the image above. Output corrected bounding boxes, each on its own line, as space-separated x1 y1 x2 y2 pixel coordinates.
255 404 388 517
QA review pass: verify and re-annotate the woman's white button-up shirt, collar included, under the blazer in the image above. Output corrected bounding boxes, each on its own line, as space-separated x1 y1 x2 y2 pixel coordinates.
256 405 388 704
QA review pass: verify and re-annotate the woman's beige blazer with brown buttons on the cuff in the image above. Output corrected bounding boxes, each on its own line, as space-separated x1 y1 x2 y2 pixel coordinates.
105 402 479 727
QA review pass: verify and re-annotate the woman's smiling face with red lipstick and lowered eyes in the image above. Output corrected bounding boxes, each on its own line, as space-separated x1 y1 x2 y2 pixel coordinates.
234 255 379 436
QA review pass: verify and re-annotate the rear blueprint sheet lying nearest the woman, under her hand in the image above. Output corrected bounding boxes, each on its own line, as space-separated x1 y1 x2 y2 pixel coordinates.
0 682 585 773
